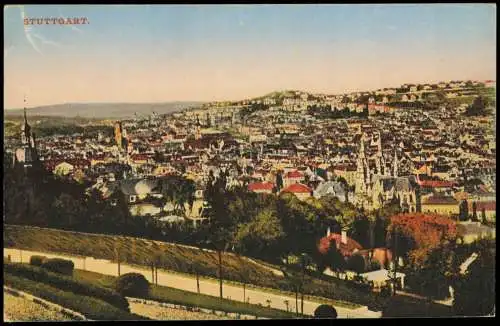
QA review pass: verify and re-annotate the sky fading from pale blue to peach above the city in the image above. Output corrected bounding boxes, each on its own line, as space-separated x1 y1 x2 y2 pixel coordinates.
4 4 496 109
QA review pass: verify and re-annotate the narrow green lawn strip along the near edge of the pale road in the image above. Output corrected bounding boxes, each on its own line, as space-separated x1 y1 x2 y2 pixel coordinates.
73 270 296 318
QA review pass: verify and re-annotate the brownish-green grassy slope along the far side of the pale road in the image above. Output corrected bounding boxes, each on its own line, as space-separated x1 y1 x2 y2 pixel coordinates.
4 225 451 316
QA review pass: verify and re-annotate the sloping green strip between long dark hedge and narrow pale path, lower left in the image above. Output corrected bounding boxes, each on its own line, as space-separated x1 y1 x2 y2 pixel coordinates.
4 272 147 320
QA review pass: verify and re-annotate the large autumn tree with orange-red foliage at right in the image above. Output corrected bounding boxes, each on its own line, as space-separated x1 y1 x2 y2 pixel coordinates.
387 213 457 265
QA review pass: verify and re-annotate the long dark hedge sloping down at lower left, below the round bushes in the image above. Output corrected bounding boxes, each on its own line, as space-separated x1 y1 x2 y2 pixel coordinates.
4 264 129 311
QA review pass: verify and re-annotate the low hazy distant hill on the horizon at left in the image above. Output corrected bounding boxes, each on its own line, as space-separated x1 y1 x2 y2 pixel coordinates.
4 102 202 119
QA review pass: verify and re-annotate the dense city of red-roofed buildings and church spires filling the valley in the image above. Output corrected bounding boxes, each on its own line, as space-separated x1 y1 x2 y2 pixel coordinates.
7 81 496 225
